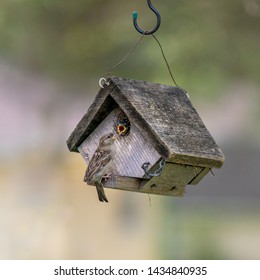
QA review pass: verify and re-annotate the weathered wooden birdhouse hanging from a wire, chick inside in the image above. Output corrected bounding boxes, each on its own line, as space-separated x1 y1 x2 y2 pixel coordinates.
67 77 224 196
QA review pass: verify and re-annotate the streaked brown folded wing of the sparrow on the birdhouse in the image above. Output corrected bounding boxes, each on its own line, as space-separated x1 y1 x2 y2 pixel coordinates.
84 149 111 181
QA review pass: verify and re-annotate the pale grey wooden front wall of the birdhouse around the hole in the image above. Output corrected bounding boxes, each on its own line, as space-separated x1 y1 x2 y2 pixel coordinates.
79 107 160 178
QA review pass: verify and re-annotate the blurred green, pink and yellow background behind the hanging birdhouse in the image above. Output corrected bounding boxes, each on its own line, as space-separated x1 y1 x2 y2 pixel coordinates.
0 0 260 259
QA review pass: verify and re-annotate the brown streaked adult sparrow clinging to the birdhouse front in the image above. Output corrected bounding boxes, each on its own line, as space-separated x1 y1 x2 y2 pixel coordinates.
84 133 116 202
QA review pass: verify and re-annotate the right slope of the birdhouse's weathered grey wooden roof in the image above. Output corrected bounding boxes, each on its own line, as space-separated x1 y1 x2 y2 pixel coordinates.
108 77 224 167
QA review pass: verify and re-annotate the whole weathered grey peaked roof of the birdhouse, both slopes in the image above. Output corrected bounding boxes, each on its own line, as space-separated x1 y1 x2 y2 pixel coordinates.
67 77 224 168
